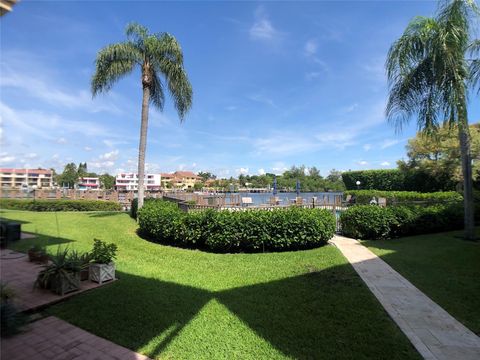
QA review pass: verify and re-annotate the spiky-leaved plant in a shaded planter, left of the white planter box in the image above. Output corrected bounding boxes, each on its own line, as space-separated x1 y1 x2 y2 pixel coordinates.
35 248 81 296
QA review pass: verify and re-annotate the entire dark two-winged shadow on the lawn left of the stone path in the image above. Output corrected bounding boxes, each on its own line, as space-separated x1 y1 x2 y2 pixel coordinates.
47 265 415 359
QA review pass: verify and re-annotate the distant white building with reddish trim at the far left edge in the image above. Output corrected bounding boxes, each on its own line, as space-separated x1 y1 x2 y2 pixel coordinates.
0 168 53 189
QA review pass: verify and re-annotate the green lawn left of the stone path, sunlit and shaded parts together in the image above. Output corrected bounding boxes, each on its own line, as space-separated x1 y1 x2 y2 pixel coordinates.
2 211 420 359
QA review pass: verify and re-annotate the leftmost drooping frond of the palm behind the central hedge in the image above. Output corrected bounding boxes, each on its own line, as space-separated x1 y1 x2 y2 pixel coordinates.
91 42 142 96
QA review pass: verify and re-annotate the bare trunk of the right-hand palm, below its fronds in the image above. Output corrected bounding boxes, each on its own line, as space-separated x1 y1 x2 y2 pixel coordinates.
458 113 475 240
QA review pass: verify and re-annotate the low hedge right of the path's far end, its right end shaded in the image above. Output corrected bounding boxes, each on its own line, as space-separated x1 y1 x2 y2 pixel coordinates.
340 203 463 240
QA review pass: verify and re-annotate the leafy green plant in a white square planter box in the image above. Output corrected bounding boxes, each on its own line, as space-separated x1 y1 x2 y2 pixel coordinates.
89 239 117 284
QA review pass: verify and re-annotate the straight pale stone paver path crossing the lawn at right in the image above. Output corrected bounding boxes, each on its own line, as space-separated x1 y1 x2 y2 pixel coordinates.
330 236 480 360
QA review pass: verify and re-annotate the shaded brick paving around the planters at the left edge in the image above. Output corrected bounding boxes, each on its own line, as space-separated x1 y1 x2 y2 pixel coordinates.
0 249 115 311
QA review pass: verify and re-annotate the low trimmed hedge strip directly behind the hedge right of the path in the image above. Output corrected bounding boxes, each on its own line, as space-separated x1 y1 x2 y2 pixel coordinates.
344 190 463 204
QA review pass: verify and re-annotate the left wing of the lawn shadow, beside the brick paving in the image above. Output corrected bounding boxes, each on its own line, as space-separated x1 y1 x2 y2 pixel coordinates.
49 271 212 357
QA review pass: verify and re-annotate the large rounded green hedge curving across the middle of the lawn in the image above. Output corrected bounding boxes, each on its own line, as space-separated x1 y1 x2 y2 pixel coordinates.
138 201 335 252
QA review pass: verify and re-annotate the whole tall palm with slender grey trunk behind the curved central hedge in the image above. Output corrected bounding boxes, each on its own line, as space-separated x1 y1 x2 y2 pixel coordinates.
92 23 192 209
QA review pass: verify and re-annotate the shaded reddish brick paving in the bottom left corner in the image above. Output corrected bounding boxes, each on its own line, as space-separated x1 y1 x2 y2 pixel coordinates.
1 316 149 360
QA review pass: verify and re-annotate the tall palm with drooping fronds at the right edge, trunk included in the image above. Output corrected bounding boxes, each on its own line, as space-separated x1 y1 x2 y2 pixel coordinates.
386 0 478 239
